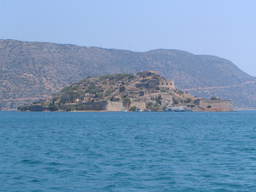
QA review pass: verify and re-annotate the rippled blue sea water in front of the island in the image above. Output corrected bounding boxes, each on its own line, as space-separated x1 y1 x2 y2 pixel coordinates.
0 112 256 192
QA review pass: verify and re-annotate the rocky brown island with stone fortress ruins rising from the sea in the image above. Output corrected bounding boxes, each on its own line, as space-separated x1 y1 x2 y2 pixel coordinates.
18 71 233 112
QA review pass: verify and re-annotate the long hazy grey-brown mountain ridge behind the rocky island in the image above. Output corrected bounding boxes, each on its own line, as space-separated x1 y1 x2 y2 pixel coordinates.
0 40 256 109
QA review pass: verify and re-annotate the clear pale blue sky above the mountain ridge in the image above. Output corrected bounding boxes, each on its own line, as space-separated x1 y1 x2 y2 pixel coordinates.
0 0 256 76
